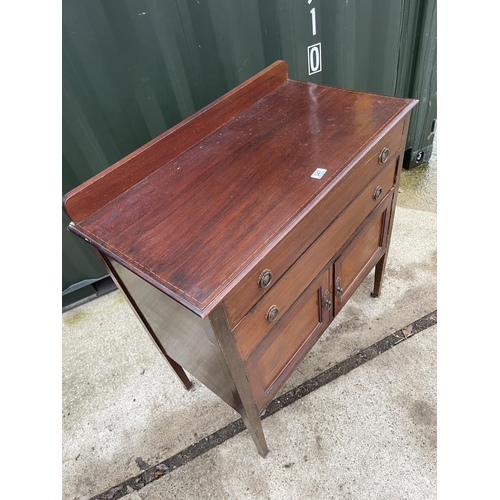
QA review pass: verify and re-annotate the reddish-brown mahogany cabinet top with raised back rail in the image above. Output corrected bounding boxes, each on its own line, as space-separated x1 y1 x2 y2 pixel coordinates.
64 61 414 317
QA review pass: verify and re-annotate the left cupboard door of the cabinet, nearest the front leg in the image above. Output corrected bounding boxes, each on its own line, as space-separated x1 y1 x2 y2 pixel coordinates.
245 267 333 411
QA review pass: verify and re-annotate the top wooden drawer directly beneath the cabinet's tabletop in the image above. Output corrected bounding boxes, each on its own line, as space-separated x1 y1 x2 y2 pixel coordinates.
224 116 404 329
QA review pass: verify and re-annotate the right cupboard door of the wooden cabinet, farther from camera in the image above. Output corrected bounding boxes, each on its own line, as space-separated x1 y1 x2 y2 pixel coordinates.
333 193 393 314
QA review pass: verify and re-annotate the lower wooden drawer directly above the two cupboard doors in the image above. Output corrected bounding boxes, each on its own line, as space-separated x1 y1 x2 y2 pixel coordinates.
233 156 396 360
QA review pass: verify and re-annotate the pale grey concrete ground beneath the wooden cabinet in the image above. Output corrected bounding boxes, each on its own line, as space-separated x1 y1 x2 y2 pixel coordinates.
62 142 437 500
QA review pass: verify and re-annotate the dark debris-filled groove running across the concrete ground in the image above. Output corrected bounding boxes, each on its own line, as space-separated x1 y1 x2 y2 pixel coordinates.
90 310 437 500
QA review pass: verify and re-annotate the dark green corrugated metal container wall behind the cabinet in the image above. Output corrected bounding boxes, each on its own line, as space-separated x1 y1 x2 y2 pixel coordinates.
62 0 436 303
